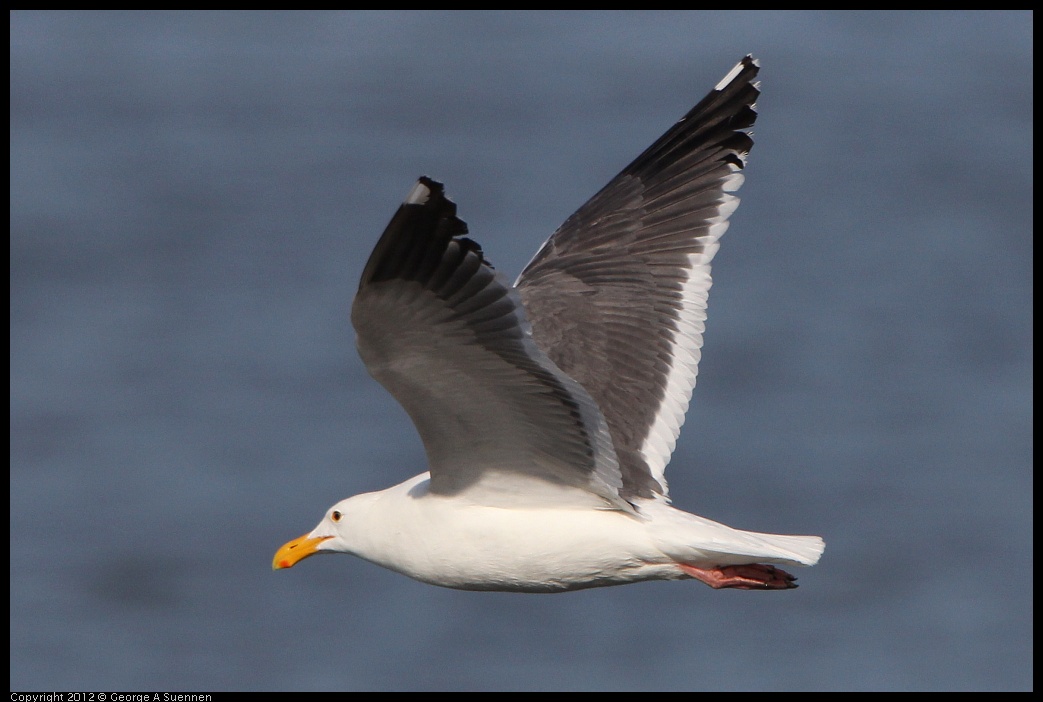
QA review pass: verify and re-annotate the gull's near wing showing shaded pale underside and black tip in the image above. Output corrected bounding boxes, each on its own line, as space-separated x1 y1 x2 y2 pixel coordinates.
351 177 629 509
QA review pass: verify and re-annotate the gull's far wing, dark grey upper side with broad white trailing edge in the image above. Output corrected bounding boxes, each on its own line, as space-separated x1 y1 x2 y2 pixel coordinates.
516 56 759 499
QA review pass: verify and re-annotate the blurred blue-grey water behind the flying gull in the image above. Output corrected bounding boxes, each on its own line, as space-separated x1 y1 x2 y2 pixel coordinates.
10 11 1033 692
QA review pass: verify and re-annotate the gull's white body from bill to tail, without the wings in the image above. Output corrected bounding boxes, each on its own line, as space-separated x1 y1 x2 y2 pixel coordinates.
276 473 824 592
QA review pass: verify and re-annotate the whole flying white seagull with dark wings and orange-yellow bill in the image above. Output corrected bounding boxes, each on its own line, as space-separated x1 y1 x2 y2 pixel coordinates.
272 55 825 592
